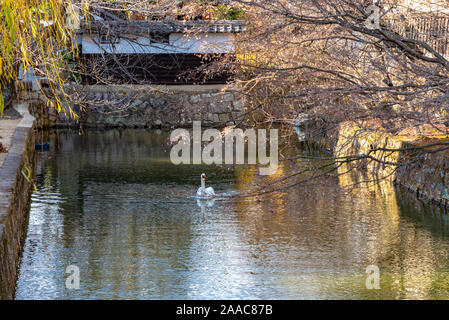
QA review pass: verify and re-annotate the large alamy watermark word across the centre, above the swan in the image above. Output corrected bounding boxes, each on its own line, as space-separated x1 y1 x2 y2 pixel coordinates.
170 121 279 175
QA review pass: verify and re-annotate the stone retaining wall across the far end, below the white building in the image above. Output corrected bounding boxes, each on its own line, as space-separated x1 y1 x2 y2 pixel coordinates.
21 86 245 128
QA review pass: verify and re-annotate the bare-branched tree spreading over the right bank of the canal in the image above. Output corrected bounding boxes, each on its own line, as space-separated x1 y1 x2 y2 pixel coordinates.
185 0 449 192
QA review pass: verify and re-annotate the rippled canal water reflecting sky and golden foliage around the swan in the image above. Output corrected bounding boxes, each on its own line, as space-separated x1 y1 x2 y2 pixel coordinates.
16 130 449 299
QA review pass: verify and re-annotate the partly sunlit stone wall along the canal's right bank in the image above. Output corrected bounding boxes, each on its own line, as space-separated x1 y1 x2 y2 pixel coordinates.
303 121 449 209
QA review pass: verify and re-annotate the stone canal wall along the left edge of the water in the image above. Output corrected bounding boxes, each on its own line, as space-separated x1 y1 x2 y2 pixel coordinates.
0 126 34 300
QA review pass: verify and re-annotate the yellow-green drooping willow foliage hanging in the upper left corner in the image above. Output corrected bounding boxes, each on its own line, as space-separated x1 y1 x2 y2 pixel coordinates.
0 0 88 115
